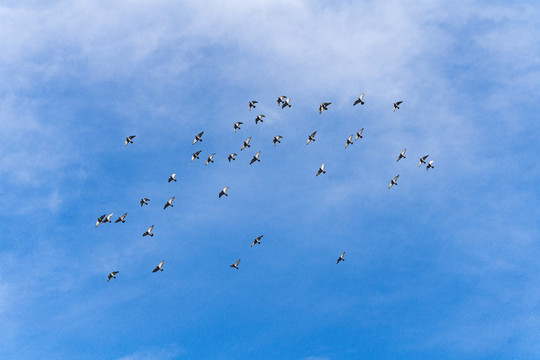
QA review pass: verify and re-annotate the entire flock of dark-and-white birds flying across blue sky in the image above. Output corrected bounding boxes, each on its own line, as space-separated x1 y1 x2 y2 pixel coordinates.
96 94 434 282
